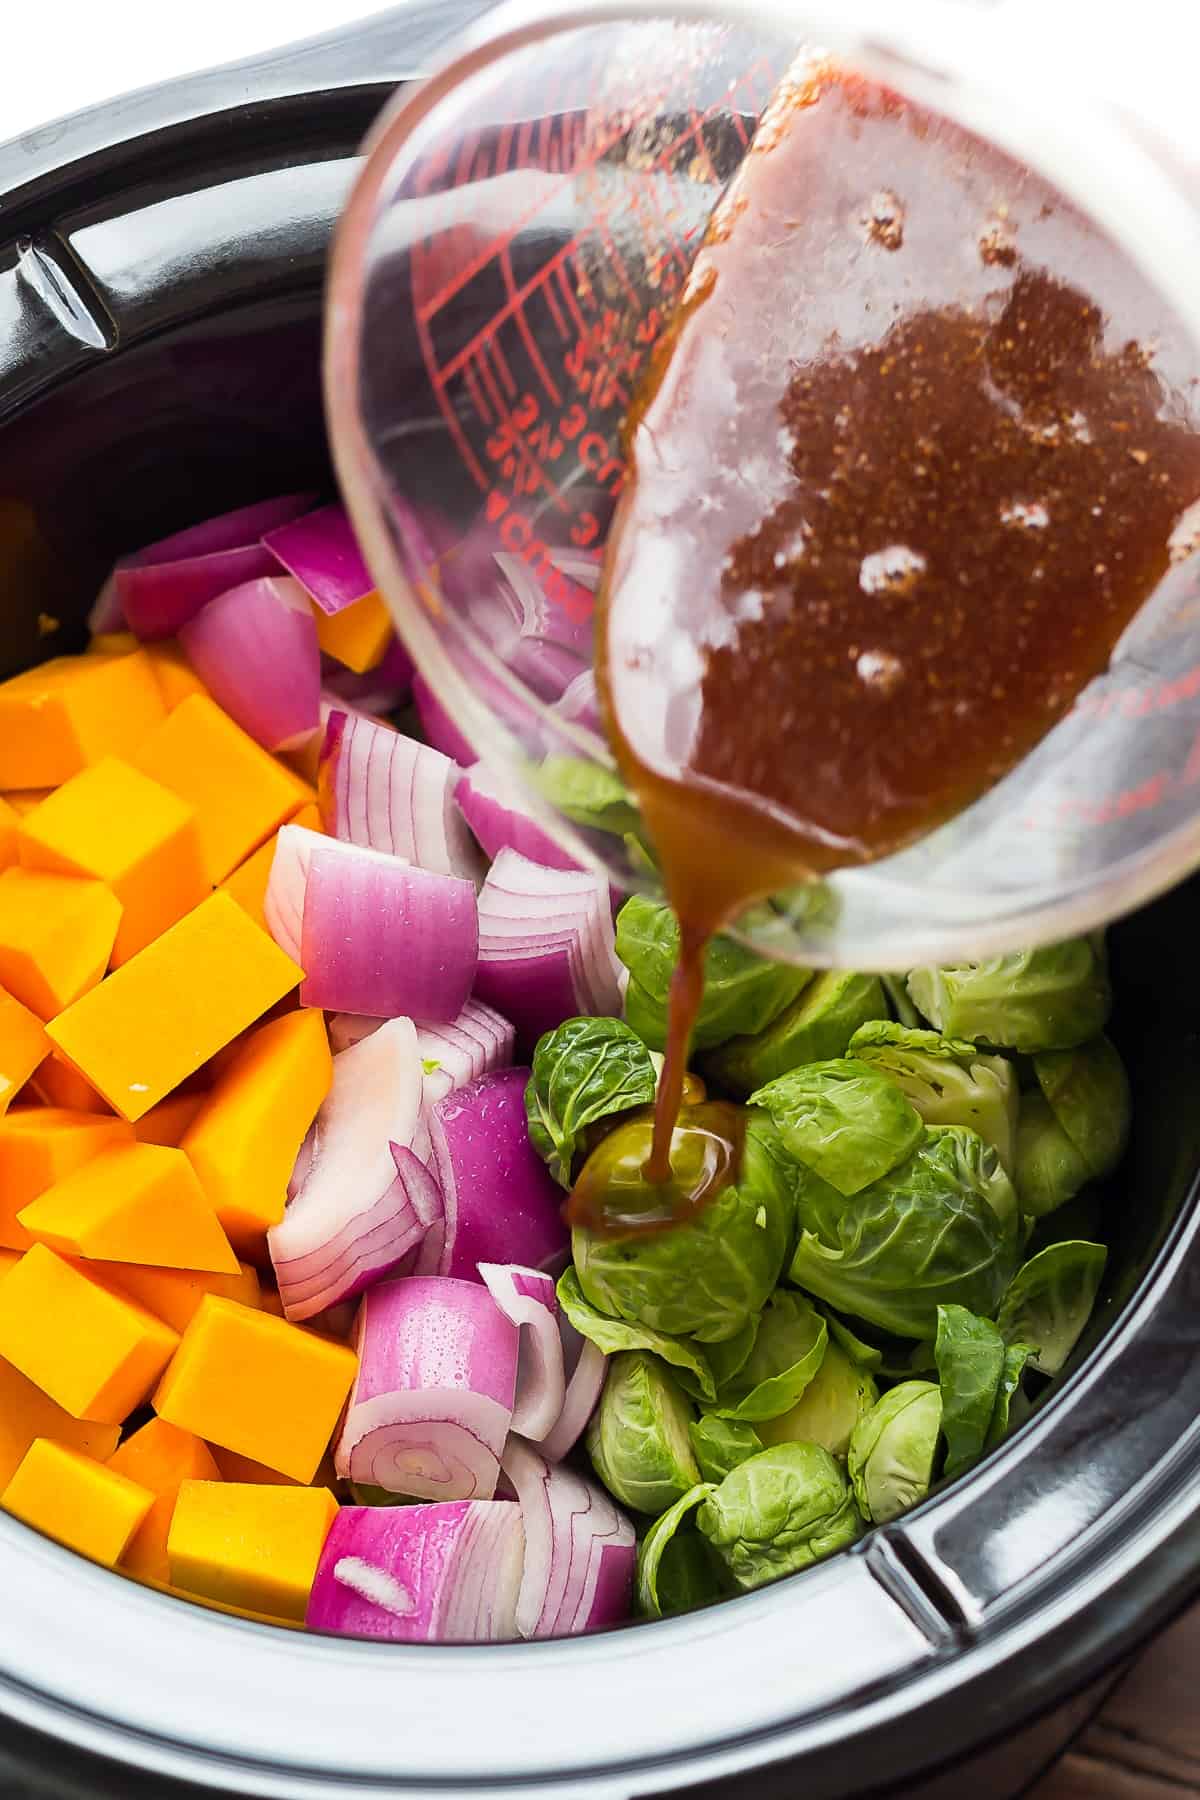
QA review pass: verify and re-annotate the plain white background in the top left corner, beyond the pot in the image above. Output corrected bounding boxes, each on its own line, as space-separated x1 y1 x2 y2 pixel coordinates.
0 0 387 142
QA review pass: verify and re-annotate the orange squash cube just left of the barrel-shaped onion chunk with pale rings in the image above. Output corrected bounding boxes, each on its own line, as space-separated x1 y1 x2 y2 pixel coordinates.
153 1303 358 1483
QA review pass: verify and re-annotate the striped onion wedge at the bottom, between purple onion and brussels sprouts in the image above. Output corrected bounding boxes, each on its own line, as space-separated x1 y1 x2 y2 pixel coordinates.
504 1438 637 1638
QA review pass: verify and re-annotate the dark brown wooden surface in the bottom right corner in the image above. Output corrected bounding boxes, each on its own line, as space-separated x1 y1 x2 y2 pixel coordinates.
1027 1607 1200 1800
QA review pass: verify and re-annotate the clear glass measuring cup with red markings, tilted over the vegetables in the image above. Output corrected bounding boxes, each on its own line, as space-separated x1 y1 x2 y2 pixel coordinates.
327 0 1200 968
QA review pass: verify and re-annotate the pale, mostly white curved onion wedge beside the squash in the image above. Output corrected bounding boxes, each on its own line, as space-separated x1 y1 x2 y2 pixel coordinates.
266 1019 431 1319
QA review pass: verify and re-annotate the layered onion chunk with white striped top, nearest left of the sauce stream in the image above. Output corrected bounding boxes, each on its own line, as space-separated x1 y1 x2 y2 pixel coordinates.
475 850 621 1048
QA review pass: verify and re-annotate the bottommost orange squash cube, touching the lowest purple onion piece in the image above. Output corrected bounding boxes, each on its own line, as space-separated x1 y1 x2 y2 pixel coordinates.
167 1481 338 1622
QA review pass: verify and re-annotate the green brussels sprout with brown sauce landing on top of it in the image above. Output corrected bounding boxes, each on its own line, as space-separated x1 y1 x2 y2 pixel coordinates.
572 1118 792 1348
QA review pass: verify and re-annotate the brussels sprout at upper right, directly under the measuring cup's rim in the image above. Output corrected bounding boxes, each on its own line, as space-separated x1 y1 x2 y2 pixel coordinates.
909 938 1112 1051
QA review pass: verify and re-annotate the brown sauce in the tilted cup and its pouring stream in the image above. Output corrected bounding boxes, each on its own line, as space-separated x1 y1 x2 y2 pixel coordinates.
592 61 1200 1229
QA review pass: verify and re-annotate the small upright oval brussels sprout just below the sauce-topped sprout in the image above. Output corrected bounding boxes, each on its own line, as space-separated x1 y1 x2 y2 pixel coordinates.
585 1350 700 1514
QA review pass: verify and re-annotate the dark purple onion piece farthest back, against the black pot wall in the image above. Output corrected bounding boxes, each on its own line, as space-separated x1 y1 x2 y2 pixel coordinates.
113 493 313 637
